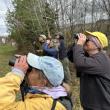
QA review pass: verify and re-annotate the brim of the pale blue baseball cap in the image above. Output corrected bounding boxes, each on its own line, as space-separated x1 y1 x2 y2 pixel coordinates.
27 53 41 70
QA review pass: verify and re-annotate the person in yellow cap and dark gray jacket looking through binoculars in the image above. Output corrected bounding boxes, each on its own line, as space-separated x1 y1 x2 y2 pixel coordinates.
68 31 110 110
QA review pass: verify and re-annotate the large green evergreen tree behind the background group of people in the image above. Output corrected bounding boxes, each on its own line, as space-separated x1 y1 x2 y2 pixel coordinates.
7 0 57 53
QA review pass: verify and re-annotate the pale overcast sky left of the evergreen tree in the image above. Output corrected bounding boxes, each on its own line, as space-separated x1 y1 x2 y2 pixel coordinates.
0 0 13 36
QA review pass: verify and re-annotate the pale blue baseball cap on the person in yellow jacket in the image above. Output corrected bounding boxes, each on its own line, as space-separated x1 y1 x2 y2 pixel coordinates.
27 53 64 86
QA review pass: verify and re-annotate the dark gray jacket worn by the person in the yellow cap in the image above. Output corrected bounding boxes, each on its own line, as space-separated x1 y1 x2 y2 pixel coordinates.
73 45 110 110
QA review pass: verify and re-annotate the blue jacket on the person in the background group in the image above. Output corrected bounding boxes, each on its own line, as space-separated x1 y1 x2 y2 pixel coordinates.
42 43 58 58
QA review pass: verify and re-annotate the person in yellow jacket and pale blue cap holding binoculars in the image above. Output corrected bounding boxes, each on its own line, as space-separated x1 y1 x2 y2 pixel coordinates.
0 53 72 110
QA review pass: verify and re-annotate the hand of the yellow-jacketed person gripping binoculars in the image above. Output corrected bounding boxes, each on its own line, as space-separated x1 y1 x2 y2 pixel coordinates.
14 56 29 73
